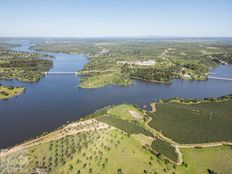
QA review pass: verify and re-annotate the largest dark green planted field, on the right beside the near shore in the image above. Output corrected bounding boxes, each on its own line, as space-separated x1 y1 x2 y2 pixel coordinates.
149 96 232 144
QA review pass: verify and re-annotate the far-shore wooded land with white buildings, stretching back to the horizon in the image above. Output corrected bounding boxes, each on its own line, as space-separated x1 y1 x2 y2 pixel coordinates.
31 39 232 88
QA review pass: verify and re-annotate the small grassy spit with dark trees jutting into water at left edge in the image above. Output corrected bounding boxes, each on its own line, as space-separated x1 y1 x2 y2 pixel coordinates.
0 85 25 100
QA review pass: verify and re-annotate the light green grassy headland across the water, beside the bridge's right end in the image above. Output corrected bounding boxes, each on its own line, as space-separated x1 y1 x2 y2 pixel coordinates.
80 72 132 88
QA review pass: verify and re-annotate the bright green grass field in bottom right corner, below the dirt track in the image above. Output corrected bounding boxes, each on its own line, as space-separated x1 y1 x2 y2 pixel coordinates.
177 146 232 174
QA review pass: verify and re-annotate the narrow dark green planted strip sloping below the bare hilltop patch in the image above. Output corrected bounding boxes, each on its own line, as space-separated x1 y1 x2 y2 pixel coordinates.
97 116 153 136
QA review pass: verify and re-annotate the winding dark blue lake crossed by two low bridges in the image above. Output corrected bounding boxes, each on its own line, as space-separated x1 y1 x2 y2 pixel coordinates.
0 41 232 148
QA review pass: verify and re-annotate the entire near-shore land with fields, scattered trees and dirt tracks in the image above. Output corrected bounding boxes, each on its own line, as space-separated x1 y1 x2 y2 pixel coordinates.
0 96 232 174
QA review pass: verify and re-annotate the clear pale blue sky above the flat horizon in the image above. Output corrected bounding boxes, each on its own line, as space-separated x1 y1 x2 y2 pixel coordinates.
0 0 232 37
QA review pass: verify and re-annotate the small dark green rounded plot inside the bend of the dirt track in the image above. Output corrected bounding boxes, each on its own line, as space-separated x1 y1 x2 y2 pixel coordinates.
151 139 178 163
